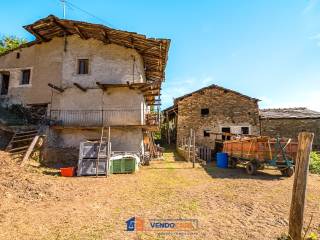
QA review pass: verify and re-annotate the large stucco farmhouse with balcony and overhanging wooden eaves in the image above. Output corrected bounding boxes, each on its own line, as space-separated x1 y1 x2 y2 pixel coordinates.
0 15 170 164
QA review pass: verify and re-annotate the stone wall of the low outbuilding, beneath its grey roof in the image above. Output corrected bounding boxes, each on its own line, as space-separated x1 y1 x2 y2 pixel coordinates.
260 119 320 150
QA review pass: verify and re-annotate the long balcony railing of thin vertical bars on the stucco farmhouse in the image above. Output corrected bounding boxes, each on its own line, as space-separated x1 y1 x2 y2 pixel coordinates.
48 109 159 127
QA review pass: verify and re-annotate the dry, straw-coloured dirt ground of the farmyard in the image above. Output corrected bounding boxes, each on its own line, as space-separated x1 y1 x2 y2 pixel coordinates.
0 151 320 240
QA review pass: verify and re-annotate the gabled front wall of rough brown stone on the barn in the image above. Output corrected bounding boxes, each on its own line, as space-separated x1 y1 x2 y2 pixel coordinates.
177 88 259 147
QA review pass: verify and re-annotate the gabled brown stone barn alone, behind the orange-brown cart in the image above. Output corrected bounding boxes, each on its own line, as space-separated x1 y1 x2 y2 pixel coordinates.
162 85 260 147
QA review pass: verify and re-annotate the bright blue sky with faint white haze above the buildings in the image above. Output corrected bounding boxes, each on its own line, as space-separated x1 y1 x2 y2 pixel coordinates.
0 0 320 111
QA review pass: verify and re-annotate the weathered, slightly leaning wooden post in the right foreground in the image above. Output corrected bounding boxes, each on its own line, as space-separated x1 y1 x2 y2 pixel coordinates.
289 132 314 240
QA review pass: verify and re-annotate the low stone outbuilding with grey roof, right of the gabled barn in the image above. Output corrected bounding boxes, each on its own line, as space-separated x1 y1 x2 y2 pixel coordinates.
260 108 320 150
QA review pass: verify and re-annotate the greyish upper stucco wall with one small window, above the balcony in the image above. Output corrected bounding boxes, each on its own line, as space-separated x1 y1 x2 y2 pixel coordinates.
62 35 145 87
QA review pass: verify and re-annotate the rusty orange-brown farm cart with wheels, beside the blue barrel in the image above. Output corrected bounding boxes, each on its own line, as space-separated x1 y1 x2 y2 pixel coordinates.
223 136 298 177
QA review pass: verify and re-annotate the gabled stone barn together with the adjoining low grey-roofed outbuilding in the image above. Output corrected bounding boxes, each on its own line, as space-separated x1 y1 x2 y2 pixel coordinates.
161 85 320 149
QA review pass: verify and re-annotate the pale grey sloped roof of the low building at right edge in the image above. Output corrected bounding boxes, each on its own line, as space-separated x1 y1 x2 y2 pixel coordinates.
260 108 320 119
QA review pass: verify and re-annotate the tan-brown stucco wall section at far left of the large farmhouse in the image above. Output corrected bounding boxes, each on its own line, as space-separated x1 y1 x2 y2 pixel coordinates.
0 38 63 104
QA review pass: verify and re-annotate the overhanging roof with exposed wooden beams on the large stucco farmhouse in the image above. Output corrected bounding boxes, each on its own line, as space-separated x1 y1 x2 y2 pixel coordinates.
0 15 170 82
